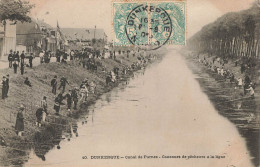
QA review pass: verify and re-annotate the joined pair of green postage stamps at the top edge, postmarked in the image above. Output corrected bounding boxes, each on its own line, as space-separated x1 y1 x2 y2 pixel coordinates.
112 1 186 49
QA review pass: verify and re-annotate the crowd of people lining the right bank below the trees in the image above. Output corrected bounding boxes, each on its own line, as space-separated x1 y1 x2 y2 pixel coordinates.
197 51 256 98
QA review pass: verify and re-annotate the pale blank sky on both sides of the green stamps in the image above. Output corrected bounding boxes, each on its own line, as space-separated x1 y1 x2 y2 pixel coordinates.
29 0 255 40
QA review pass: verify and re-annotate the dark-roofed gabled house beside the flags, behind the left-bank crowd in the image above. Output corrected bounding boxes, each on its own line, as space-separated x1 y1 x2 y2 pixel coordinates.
16 19 66 55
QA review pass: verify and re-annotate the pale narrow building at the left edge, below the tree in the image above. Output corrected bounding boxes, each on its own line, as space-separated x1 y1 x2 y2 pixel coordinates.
0 20 16 59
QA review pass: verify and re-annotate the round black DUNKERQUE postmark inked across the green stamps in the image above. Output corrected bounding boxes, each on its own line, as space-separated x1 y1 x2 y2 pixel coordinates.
125 4 173 50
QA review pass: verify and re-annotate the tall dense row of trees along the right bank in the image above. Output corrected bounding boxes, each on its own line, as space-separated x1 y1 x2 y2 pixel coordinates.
187 4 260 58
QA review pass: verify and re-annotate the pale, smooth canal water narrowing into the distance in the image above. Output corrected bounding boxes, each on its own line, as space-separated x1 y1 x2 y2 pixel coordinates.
25 50 252 167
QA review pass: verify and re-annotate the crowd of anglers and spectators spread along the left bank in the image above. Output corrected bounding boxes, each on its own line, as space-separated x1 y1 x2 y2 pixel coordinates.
2 49 155 136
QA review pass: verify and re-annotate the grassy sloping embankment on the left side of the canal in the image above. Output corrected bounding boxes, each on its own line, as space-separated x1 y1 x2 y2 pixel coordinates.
0 51 162 165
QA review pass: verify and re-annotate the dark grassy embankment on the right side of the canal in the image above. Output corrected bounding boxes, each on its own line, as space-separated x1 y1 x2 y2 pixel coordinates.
183 51 260 166
